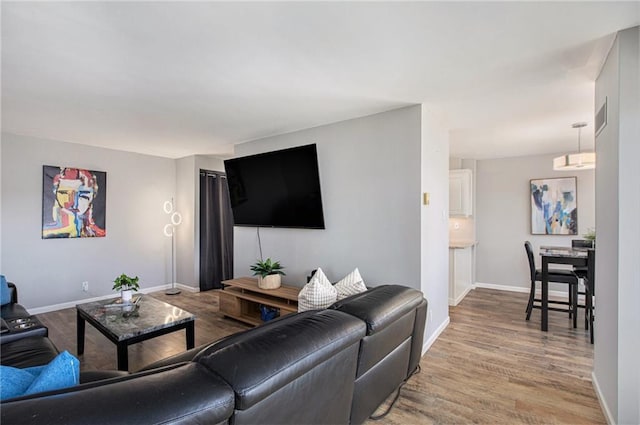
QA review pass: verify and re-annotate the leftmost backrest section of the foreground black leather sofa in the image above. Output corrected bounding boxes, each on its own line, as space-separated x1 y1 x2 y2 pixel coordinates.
0 363 234 425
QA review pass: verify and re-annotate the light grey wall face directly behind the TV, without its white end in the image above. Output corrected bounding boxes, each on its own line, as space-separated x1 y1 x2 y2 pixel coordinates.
234 106 421 288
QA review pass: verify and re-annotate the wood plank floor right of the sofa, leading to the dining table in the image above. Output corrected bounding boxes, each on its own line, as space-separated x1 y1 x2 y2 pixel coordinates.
368 289 606 425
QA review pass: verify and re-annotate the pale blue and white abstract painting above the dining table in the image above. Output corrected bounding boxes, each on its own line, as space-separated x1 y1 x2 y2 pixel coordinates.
530 177 578 235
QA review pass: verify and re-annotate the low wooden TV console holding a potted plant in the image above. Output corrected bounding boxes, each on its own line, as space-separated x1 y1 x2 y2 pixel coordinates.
218 277 302 326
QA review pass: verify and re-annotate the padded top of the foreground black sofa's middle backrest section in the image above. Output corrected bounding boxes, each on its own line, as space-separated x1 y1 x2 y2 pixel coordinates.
197 310 366 410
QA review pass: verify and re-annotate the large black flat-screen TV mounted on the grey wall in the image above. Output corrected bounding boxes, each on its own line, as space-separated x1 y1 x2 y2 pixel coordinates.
224 144 324 229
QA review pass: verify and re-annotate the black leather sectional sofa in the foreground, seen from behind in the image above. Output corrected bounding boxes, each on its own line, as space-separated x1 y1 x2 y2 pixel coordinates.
0 285 427 424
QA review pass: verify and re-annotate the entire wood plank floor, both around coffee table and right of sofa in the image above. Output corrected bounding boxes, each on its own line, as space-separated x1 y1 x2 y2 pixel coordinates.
38 289 606 425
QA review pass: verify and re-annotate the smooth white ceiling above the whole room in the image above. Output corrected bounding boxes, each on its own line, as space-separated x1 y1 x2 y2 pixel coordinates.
1 1 640 159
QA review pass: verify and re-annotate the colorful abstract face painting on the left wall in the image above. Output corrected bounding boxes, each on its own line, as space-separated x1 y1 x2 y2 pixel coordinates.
42 165 107 239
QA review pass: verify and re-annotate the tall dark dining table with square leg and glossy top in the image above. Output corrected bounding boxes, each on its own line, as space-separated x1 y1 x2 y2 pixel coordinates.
540 245 591 332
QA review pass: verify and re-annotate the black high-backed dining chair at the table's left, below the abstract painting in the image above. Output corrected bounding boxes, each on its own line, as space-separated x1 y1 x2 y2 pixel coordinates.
524 241 578 328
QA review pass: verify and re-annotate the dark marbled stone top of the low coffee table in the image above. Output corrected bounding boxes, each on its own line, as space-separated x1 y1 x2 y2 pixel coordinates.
76 295 196 341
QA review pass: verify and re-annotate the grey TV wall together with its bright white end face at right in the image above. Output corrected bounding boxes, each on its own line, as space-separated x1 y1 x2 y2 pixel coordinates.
234 106 449 343
